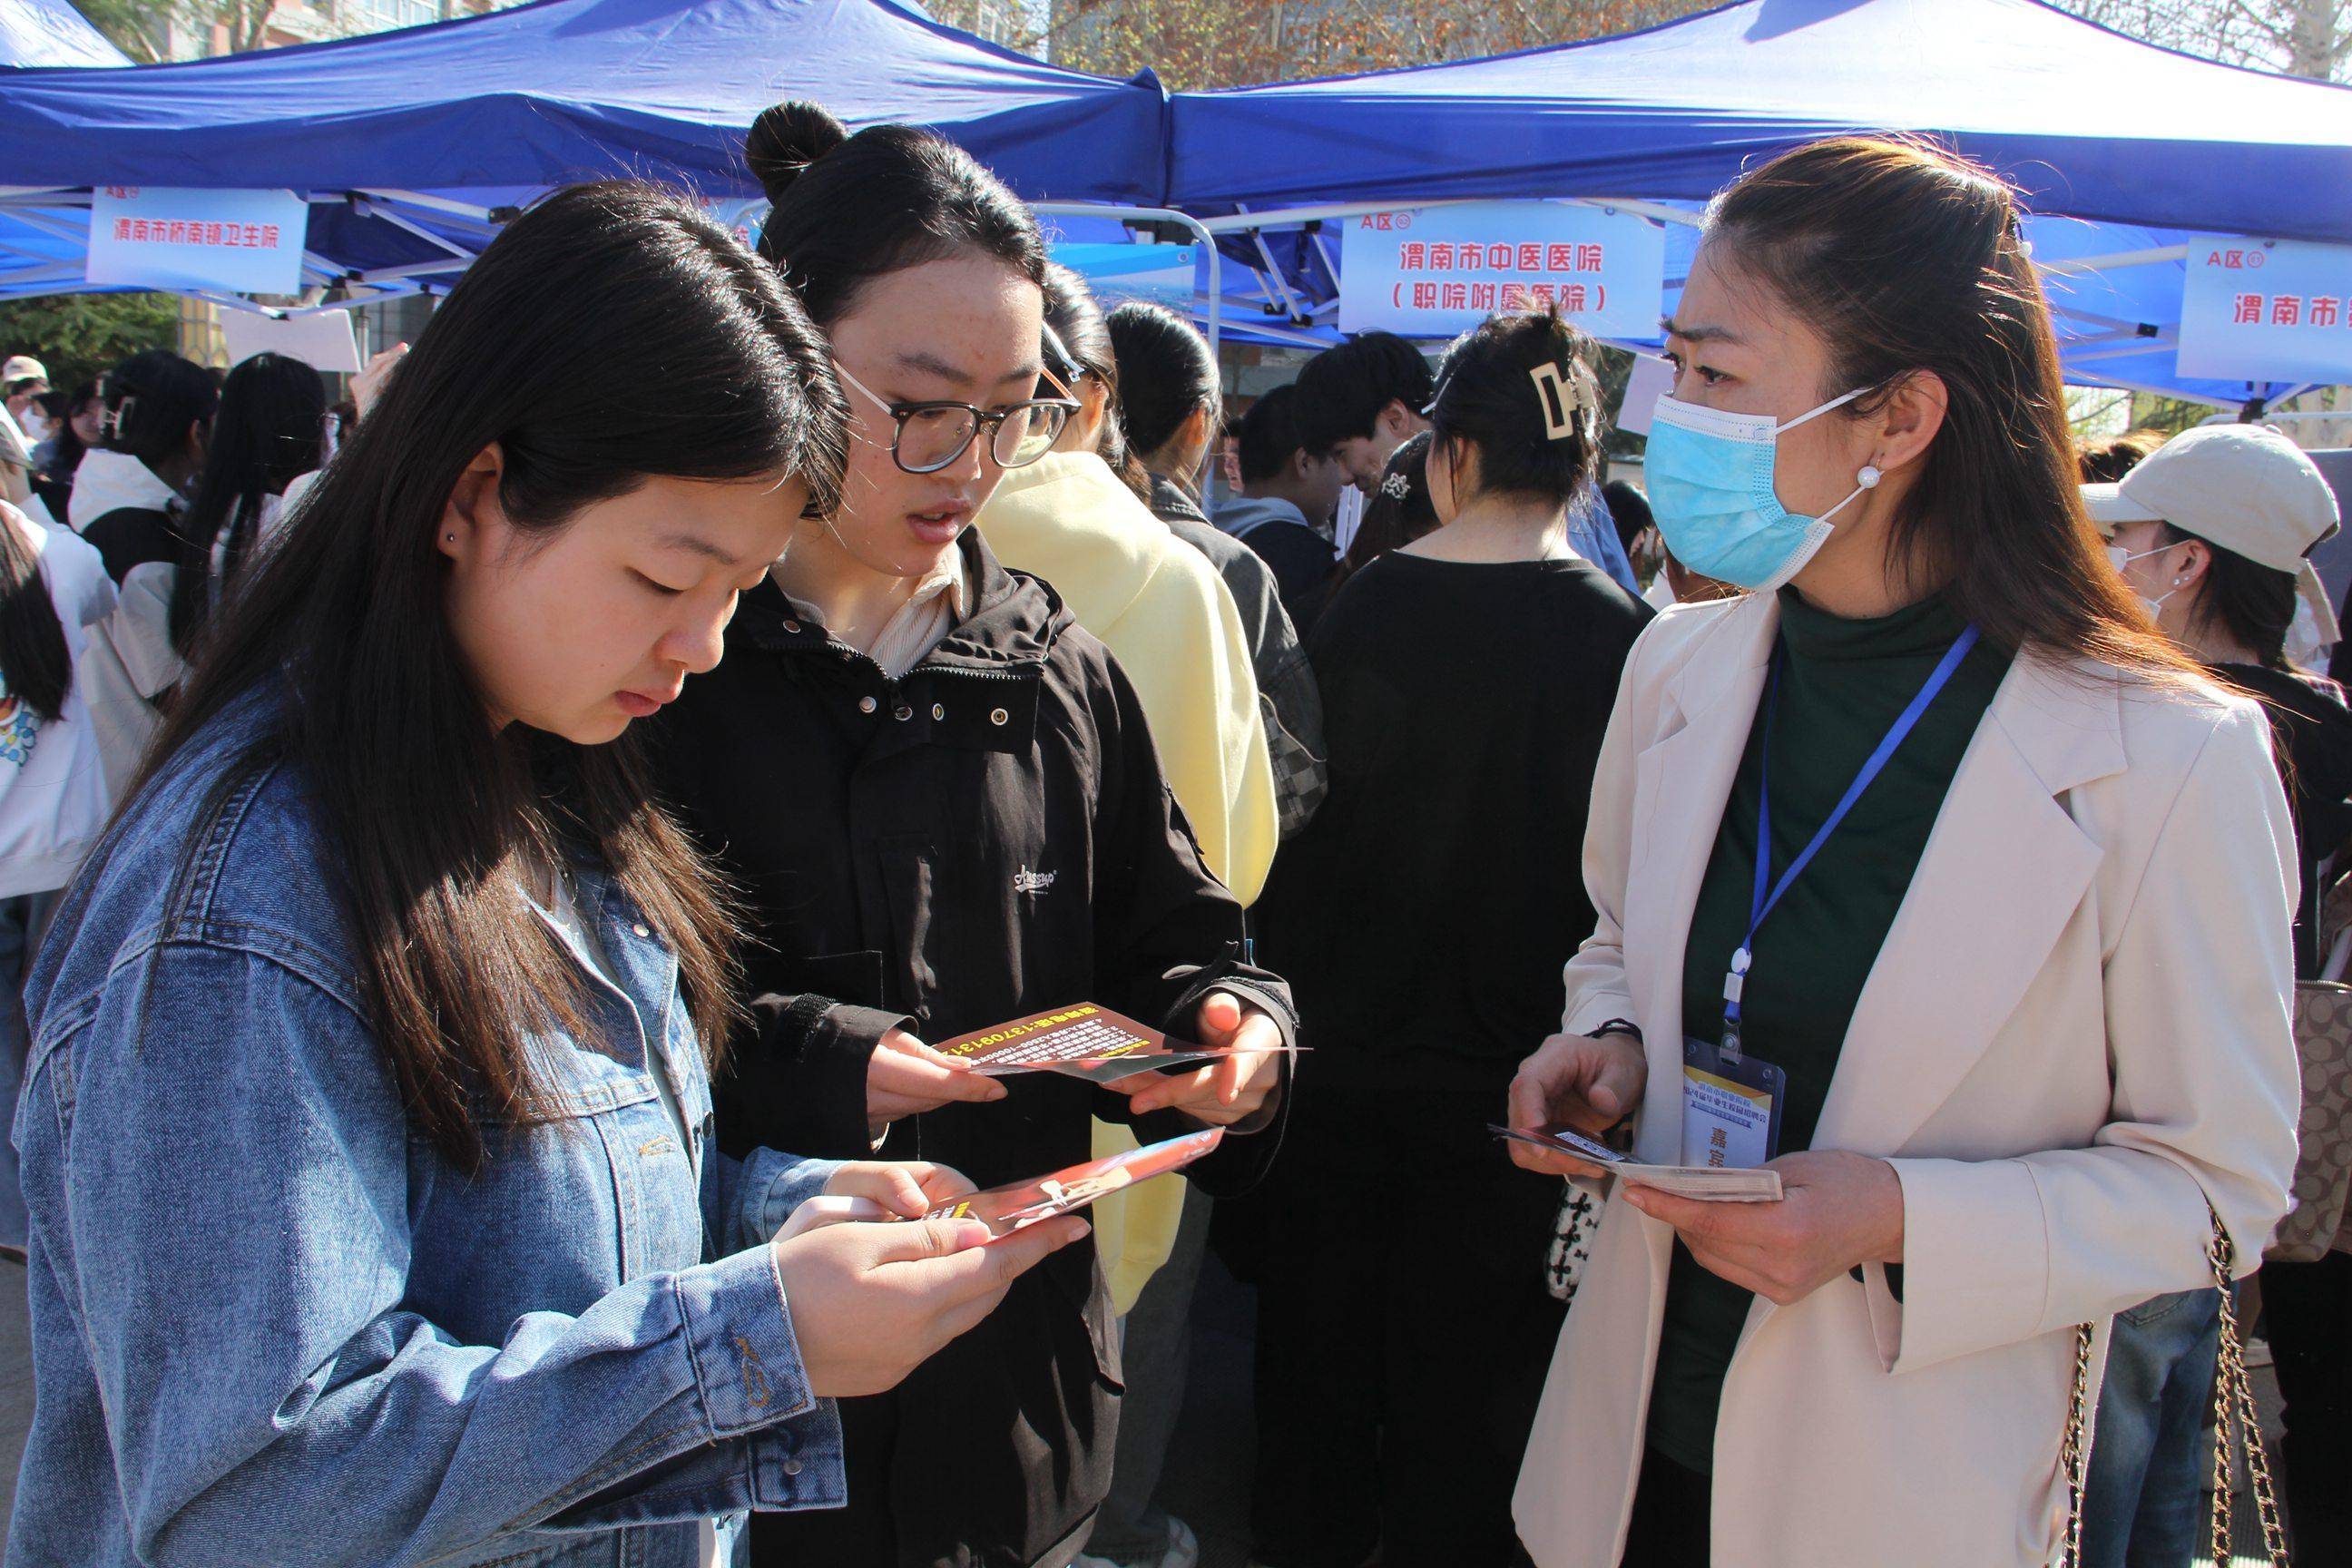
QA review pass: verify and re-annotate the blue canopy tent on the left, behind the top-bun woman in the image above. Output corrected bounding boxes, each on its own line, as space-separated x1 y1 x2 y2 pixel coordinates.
0 0 1164 303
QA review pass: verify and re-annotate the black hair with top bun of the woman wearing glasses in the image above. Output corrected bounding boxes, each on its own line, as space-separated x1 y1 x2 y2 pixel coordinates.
743 101 1046 327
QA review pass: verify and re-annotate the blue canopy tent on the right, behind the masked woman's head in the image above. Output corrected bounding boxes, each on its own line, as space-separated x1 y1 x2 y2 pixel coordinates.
1169 0 2352 405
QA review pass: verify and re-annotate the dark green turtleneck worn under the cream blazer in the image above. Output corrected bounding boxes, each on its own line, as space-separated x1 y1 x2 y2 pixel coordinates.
1649 588 2009 1472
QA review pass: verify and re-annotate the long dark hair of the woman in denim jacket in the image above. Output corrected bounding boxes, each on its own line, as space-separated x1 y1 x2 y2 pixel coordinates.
132 181 849 1169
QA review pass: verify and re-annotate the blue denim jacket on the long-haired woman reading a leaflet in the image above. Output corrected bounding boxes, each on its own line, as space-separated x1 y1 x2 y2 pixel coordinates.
7 693 845 1568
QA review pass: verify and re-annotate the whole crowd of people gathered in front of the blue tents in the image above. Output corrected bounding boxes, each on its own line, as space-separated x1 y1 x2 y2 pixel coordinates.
0 103 2352 1568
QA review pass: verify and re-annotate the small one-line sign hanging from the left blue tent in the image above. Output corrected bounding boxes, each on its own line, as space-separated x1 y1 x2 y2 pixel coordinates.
87 186 310 294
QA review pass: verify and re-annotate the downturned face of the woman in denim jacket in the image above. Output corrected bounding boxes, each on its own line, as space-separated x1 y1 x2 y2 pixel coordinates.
442 477 809 745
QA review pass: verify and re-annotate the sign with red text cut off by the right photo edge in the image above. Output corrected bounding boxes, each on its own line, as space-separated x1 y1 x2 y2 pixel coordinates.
2178 235 2352 381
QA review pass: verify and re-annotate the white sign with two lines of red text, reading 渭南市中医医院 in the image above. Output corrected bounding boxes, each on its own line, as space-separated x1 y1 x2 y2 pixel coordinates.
1338 202 1665 338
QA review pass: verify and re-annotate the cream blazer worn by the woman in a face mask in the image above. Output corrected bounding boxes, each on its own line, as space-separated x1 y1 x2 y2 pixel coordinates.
1517 594 2298 1568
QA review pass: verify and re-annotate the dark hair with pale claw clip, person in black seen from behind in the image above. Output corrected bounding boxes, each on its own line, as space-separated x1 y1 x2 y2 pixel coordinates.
1427 308 1602 503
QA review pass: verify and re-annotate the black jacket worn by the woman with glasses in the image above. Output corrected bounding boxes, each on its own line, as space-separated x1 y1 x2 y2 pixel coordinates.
654 529 1294 1568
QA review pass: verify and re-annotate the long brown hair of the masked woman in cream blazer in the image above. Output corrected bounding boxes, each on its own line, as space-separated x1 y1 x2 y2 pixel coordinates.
1700 136 2194 677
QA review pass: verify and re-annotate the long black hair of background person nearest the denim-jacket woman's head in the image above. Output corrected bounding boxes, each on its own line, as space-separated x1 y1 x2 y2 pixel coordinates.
172 355 327 653
